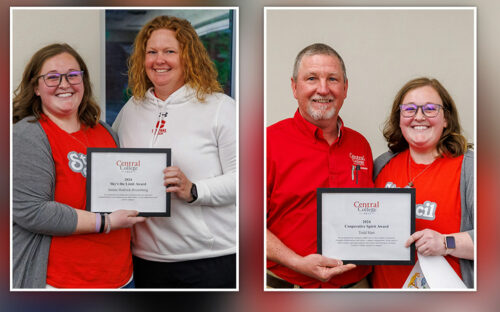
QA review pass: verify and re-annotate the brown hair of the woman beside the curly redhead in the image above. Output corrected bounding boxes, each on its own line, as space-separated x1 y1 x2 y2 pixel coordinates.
12 43 101 127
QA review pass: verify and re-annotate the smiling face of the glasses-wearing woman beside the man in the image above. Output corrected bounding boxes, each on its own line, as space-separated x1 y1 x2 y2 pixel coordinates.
399 86 447 152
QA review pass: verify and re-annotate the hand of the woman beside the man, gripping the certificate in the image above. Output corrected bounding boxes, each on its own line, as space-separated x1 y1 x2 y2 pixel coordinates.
405 229 446 256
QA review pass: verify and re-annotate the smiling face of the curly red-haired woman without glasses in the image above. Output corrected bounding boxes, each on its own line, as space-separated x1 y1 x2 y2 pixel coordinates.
144 29 184 100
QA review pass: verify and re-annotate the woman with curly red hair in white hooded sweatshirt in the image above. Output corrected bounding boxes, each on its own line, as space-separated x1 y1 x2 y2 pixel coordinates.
113 16 236 288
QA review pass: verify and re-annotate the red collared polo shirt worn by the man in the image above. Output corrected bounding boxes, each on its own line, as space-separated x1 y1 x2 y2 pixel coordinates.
267 111 373 288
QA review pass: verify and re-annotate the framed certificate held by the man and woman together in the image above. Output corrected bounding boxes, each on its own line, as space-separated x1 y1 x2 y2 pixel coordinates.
317 188 415 265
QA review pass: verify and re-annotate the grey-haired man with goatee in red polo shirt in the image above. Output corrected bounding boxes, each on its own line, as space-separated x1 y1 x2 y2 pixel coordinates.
266 43 373 288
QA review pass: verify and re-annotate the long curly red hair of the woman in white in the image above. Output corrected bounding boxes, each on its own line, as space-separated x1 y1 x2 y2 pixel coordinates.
128 16 222 101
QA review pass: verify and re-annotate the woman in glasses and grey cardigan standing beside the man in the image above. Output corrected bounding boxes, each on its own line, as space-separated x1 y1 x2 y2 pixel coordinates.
372 77 474 288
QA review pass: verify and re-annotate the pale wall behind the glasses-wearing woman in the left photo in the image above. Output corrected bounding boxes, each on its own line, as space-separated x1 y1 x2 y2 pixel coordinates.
11 8 105 112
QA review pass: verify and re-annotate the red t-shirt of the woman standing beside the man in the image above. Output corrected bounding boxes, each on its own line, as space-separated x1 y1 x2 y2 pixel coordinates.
372 150 463 288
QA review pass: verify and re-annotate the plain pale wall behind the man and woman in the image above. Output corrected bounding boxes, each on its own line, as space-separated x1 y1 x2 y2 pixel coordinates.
264 8 475 157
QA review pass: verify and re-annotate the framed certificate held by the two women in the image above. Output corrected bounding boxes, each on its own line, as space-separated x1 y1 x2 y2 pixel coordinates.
87 148 171 217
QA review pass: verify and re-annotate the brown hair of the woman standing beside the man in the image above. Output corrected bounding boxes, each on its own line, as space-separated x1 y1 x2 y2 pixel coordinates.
383 77 472 157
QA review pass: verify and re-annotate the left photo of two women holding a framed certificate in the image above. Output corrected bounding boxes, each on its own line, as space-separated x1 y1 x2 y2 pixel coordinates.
10 7 239 291
